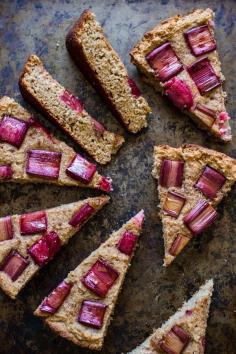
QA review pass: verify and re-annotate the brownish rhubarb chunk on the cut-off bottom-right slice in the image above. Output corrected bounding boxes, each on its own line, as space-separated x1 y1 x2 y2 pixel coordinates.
159 326 190 354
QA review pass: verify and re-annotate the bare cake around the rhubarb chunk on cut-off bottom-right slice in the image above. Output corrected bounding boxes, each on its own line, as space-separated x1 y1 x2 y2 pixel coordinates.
130 280 213 354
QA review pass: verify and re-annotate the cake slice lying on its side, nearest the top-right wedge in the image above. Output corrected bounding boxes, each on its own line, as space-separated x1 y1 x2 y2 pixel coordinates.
66 10 151 133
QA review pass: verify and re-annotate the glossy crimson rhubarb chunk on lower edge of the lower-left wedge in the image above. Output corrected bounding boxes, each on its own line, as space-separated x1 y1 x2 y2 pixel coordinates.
28 231 61 267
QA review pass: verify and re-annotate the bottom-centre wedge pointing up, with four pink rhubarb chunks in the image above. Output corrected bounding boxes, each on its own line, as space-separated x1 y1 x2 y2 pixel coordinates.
34 211 144 350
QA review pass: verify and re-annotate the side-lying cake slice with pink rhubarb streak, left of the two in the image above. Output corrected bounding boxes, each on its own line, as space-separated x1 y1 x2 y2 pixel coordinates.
19 55 124 164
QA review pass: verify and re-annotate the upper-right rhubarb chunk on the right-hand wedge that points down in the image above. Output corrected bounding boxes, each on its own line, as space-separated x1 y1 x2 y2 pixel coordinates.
196 166 226 199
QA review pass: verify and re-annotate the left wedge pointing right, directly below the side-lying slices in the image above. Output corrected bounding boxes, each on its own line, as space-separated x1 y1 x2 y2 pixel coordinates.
0 96 111 192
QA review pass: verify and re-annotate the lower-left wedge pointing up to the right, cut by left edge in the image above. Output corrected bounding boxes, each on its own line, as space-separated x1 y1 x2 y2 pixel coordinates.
0 196 110 299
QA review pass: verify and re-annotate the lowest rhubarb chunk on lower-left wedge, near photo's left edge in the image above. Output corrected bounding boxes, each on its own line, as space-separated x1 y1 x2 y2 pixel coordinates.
0 251 29 281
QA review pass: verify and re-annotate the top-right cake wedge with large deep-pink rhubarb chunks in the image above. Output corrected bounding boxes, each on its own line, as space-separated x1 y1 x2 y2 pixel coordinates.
130 9 232 142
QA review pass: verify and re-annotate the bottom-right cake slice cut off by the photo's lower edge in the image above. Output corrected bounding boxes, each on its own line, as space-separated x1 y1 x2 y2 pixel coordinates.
130 279 213 354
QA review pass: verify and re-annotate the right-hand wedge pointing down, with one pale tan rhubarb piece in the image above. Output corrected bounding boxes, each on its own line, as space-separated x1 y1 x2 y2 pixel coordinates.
152 145 236 266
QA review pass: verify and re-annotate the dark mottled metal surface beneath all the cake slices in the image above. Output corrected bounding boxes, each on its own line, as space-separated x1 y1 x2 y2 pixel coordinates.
0 0 236 354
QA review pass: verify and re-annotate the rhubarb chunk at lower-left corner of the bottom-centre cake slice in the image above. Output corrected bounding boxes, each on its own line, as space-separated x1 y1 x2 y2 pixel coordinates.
39 281 73 313
